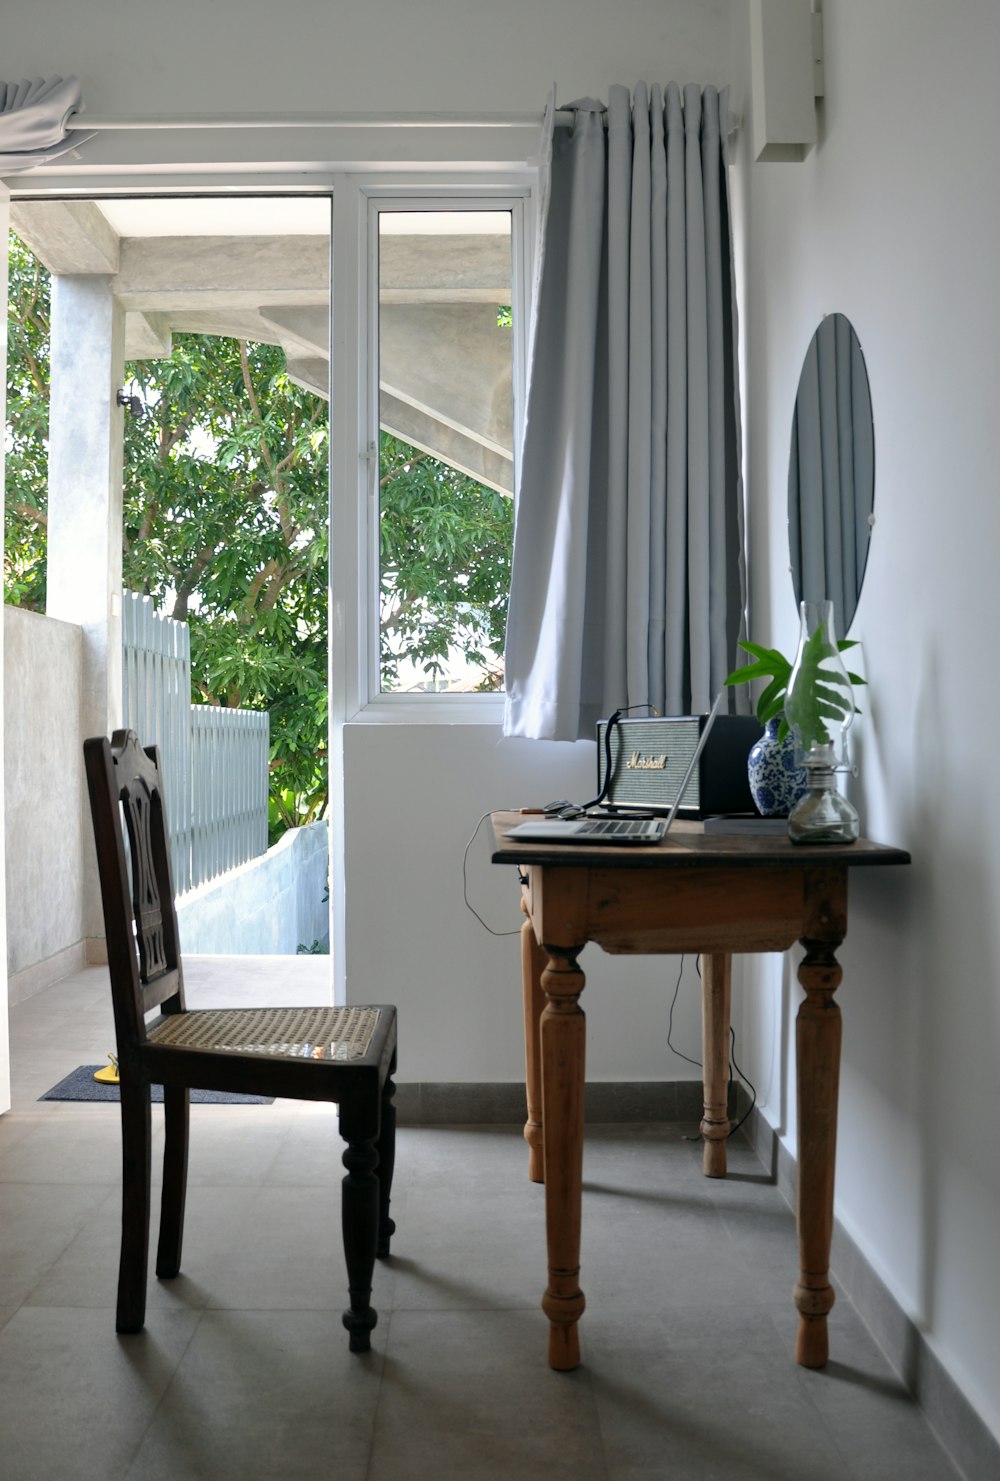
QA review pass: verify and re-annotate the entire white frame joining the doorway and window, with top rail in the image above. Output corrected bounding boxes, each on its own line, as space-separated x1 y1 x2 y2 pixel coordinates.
7 141 541 1018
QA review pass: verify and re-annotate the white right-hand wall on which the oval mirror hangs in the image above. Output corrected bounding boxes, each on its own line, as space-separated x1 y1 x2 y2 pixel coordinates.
738 0 1000 1434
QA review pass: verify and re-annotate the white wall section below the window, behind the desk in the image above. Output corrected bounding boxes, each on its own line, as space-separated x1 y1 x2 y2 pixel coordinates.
345 724 711 1081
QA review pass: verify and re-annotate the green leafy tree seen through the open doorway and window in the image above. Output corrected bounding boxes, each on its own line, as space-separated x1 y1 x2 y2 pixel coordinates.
4 235 513 831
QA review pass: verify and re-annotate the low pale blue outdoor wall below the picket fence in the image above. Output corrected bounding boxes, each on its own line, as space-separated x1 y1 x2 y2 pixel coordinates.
178 823 330 957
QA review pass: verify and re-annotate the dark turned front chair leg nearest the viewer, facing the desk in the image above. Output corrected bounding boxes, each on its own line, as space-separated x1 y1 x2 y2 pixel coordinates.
341 1105 379 1352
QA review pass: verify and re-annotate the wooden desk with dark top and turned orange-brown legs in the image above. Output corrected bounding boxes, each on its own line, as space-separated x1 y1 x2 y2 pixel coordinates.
492 813 910 1368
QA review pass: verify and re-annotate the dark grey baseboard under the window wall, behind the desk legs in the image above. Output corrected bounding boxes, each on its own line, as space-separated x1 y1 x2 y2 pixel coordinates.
396 1080 739 1126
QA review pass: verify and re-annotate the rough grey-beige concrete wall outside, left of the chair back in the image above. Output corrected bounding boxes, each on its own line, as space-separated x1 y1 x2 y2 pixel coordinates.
3 607 93 1003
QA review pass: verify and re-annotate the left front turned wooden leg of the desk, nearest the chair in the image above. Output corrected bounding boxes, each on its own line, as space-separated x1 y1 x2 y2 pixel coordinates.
541 946 587 1370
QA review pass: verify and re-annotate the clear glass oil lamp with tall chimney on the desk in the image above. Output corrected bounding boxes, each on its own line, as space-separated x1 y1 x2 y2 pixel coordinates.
785 601 861 844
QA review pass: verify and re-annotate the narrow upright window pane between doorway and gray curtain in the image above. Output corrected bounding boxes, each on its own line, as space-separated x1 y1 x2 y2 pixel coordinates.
379 209 514 693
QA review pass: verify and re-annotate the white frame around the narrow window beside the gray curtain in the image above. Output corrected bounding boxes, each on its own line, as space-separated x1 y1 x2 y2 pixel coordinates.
330 170 533 724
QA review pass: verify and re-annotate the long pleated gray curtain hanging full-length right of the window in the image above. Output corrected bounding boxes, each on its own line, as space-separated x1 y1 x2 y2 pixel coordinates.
504 83 745 741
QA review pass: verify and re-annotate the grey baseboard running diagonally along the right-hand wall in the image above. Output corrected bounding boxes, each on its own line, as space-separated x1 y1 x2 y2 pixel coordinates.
742 1109 1000 1481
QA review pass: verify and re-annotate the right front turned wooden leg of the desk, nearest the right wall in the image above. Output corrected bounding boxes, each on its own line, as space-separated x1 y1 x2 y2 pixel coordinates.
796 940 841 1368
